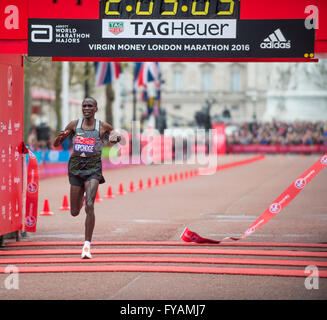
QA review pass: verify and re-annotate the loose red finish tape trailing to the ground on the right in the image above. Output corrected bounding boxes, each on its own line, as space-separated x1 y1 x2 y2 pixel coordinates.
181 154 327 243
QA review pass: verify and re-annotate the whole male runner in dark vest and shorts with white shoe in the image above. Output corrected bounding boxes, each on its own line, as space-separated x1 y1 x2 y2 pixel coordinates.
54 97 125 259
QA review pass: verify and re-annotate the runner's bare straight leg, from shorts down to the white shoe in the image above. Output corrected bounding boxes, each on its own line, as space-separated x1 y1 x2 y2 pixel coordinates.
84 179 99 242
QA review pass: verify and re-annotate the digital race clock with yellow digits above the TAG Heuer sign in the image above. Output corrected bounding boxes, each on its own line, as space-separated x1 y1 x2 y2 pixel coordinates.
100 0 240 19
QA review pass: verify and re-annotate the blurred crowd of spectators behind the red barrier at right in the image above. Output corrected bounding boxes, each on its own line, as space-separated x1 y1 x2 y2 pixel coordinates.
226 121 327 145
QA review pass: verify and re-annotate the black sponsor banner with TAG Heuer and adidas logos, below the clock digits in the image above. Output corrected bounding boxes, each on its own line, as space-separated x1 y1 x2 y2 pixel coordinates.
28 19 315 60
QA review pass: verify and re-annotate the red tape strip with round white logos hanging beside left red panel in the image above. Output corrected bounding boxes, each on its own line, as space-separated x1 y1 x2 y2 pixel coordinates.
24 150 39 232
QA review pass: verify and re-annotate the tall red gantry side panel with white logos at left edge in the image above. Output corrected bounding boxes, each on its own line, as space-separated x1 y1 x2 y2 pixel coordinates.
0 53 24 235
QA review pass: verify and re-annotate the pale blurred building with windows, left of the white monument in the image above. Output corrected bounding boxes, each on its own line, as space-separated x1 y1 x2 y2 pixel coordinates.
122 62 271 126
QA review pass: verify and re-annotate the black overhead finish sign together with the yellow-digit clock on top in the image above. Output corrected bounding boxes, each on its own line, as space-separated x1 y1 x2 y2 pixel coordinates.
28 0 315 61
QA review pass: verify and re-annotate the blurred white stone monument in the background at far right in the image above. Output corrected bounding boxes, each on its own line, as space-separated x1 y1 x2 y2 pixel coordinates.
263 59 327 122
